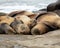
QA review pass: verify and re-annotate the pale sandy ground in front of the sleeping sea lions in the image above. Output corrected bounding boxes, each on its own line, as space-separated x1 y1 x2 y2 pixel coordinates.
0 30 60 48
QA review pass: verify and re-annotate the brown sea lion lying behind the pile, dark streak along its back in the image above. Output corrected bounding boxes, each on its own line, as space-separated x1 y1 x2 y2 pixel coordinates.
8 11 38 18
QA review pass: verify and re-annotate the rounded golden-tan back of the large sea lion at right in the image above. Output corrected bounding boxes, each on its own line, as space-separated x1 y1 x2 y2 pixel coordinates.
37 12 59 23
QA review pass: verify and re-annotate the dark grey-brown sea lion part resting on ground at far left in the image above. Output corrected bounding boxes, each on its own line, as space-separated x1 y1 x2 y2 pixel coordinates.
0 23 16 34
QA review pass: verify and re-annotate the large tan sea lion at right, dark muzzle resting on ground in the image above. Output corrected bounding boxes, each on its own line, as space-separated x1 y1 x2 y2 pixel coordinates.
31 12 59 34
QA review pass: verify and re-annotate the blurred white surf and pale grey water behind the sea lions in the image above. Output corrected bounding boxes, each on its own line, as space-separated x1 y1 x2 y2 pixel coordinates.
0 0 57 13
